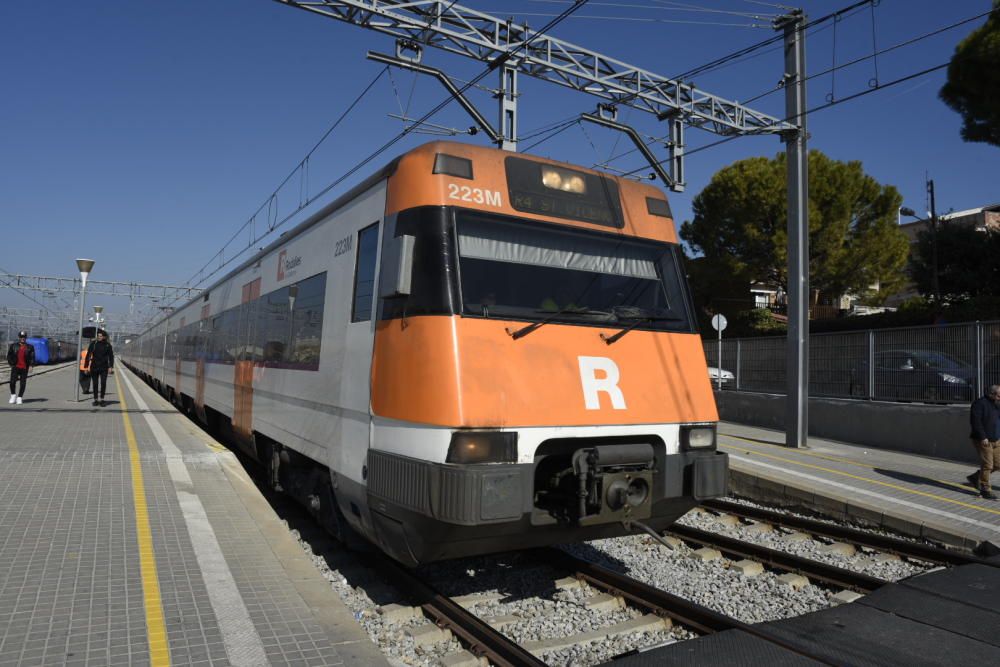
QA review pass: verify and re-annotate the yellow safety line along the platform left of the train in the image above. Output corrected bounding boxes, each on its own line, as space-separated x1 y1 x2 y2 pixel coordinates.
114 374 170 667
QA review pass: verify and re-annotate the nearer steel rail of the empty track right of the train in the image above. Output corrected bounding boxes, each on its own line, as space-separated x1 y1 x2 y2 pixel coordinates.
666 525 890 593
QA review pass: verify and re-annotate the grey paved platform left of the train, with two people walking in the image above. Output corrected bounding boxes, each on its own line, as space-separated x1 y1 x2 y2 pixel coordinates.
0 364 387 665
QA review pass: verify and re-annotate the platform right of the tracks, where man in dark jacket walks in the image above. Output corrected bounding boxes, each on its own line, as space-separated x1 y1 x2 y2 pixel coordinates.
719 422 1000 556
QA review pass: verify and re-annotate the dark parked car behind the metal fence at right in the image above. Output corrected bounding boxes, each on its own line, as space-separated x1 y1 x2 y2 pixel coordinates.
852 349 976 403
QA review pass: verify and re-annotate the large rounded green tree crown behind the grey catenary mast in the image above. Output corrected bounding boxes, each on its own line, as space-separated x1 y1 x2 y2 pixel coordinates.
681 151 909 302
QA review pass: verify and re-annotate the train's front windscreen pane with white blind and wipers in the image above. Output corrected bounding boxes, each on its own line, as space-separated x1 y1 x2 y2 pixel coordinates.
455 211 692 332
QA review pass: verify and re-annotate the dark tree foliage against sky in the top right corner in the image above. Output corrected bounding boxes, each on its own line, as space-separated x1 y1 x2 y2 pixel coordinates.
939 0 1000 146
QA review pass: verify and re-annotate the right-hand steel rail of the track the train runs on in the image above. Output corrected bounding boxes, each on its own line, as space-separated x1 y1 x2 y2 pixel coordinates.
541 548 833 664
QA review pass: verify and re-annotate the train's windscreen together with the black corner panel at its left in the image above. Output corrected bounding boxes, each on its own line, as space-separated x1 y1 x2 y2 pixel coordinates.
380 207 695 333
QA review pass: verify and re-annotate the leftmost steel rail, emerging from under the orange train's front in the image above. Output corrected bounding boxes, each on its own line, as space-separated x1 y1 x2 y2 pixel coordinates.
373 554 545 667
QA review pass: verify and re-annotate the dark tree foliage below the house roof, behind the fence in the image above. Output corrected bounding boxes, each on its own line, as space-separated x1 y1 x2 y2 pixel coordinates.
910 223 1000 302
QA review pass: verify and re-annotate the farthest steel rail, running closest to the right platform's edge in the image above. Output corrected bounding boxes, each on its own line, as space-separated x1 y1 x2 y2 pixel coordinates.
702 500 996 567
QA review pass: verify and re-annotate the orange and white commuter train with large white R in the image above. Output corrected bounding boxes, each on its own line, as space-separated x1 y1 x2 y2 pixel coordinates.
119 141 728 566
